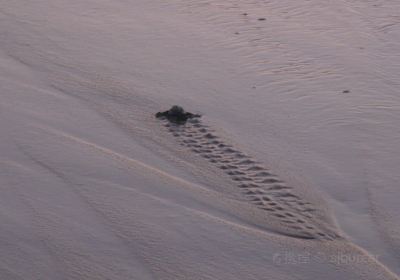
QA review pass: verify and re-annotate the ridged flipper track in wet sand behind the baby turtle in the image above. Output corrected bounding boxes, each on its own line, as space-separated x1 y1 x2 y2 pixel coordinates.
165 119 338 240
